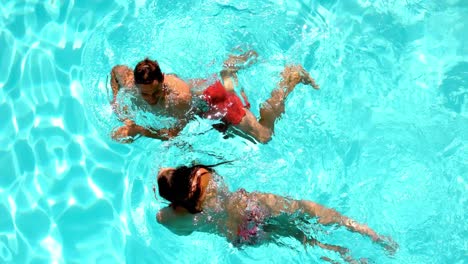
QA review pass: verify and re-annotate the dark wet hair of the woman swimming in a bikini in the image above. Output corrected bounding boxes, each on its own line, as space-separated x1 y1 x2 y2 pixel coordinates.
158 165 213 214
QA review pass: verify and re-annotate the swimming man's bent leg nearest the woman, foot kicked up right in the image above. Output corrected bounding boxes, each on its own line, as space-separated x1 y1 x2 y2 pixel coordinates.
234 66 319 143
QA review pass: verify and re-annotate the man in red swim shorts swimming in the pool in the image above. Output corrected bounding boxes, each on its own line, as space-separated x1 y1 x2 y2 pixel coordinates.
111 51 319 143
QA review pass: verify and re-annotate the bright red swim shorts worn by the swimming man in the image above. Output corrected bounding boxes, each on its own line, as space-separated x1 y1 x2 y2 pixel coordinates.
203 81 245 125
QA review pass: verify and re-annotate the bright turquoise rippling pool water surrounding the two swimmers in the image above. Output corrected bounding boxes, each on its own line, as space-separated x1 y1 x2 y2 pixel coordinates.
0 0 468 263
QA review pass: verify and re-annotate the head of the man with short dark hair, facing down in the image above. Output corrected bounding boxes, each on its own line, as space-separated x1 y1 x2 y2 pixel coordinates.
133 58 164 105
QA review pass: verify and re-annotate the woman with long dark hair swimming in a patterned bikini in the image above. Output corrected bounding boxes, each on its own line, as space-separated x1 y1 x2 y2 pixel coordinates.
157 165 398 262
